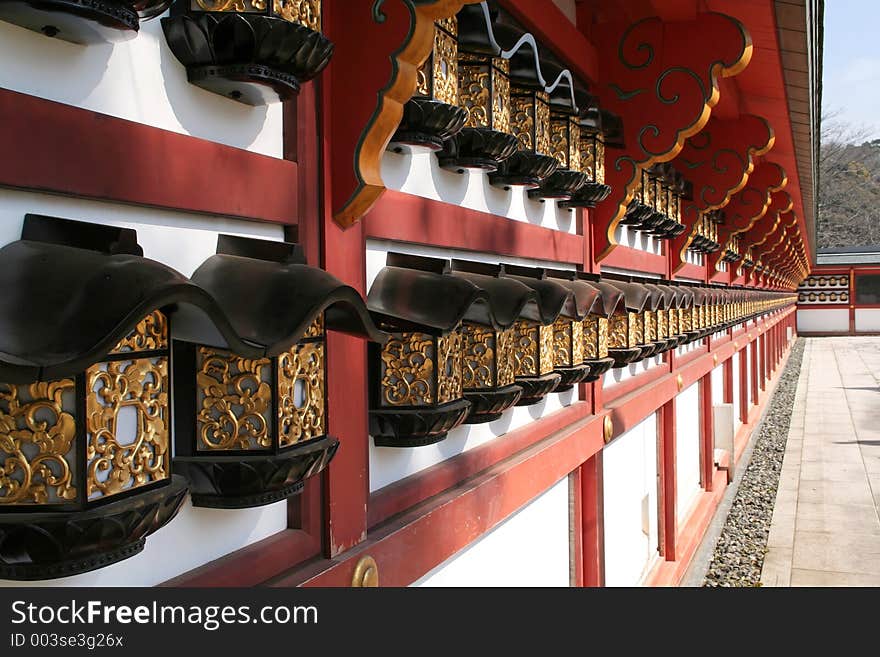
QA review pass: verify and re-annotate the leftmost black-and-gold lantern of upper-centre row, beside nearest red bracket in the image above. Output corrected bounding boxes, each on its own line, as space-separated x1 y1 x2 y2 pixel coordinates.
389 16 467 152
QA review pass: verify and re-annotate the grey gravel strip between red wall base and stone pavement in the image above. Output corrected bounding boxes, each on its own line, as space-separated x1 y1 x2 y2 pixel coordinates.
703 338 804 586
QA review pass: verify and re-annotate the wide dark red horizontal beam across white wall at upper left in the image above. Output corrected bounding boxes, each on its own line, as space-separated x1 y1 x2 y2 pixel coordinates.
0 89 298 224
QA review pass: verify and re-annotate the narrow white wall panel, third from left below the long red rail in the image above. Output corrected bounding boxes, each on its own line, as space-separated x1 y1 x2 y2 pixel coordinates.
675 383 702 520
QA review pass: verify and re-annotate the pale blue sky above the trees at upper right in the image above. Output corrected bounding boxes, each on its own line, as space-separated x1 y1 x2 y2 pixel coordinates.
822 0 880 139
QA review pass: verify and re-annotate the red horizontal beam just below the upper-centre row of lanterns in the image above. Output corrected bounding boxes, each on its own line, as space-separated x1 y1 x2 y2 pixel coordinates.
363 191 584 264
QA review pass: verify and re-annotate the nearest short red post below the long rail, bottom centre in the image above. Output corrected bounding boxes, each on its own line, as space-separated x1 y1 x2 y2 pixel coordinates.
580 451 605 587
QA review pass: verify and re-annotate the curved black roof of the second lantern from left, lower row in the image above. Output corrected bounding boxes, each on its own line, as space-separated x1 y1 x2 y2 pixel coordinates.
175 235 384 358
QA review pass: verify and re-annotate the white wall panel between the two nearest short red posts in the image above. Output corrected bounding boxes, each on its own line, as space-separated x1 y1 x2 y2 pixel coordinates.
602 414 658 586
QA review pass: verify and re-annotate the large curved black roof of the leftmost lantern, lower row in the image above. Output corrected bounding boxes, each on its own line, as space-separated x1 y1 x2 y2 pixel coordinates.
0 214 210 383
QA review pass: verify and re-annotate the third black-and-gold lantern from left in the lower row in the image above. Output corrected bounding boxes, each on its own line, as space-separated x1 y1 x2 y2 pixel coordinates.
367 253 492 447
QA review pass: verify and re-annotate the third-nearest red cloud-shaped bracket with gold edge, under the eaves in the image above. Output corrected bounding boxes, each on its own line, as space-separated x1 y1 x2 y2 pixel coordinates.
670 114 776 273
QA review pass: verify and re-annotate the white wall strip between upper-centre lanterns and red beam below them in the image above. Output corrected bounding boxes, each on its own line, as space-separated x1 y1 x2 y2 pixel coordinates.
382 149 577 235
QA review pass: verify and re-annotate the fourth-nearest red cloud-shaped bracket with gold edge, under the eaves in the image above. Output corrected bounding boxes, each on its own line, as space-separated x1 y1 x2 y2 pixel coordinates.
707 162 788 273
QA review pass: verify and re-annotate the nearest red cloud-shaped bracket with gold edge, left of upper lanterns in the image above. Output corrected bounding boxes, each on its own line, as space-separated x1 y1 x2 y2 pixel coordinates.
322 0 480 228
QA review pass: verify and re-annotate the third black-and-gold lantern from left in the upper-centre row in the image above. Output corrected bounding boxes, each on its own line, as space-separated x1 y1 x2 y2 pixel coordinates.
489 35 559 189
